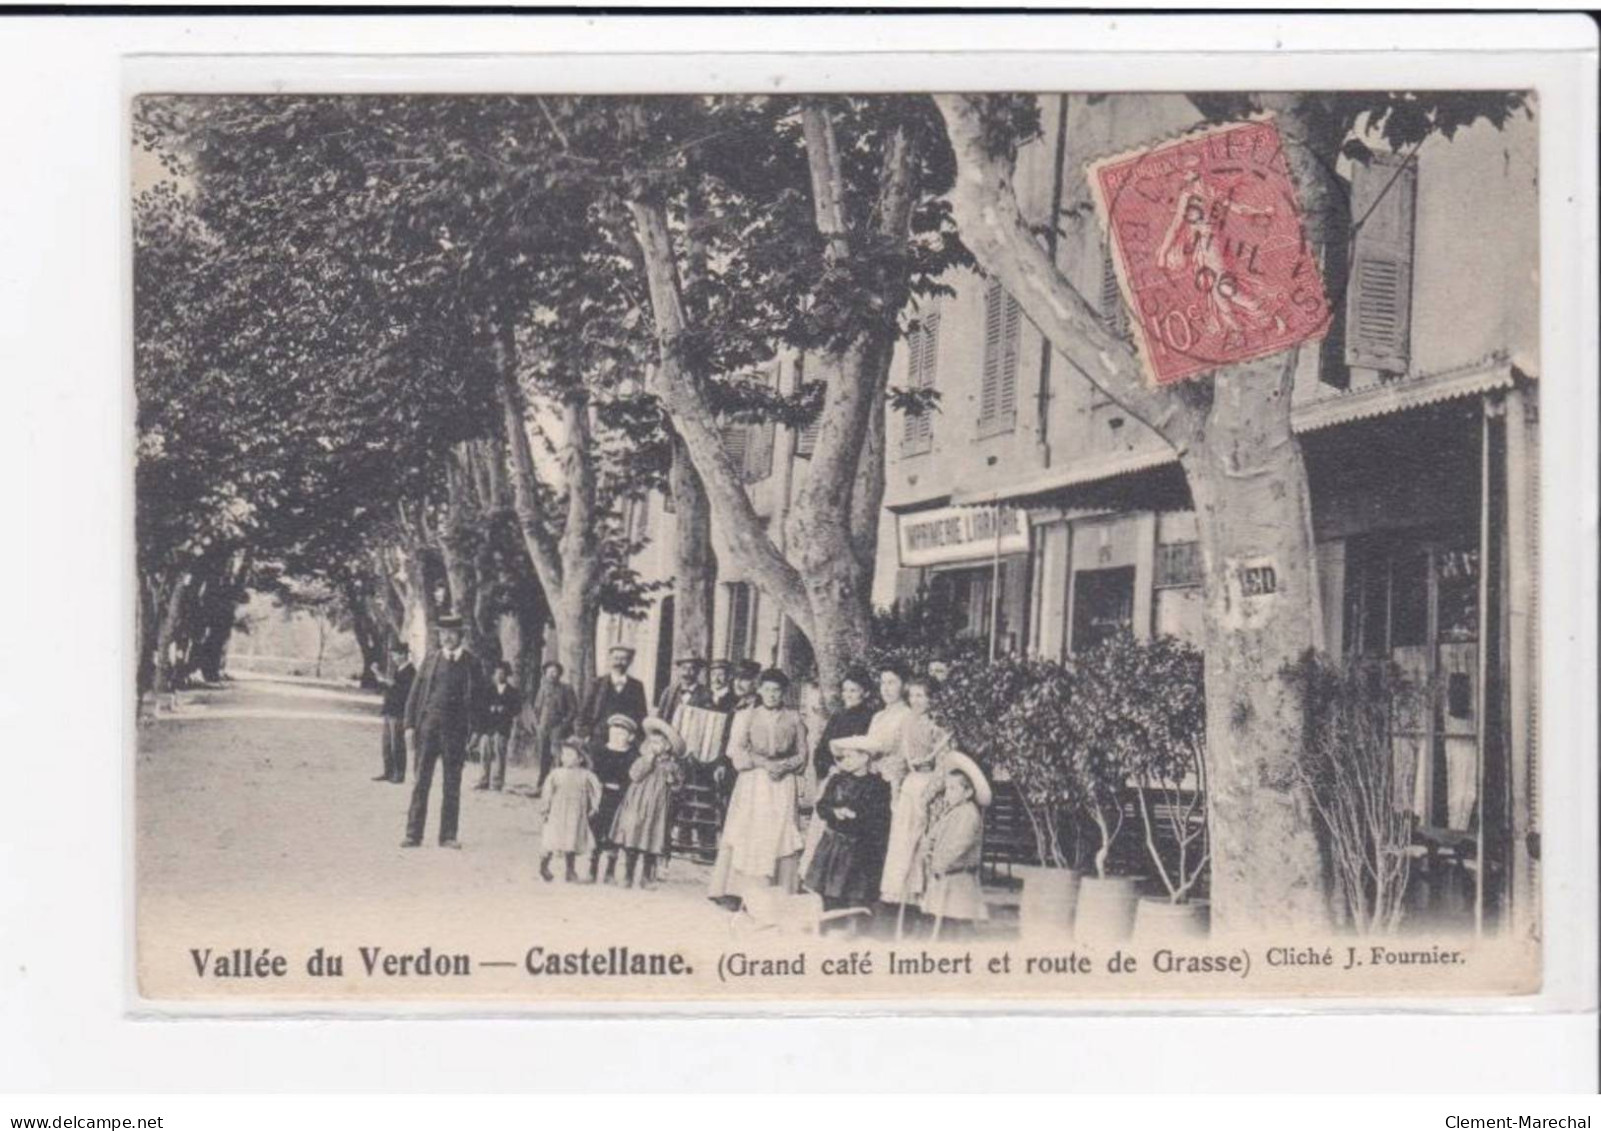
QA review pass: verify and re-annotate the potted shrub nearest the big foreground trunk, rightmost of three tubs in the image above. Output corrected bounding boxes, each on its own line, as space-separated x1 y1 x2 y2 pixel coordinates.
1121 638 1212 939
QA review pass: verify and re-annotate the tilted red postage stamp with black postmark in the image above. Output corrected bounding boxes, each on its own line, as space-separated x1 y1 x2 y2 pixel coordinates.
1089 119 1330 384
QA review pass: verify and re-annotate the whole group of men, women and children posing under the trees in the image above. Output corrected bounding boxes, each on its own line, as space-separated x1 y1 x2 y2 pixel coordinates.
378 618 991 937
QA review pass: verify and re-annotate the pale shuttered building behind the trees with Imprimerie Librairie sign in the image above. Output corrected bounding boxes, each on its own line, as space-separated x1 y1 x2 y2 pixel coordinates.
602 95 1539 929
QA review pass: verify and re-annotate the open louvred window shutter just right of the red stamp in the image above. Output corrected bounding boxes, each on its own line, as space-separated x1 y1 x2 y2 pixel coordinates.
1345 154 1417 373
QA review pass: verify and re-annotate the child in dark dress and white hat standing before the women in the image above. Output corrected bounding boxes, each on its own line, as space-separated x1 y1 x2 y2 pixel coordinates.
805 737 890 934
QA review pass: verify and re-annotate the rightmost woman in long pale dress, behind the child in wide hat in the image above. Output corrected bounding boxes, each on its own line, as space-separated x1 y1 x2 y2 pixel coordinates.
879 679 951 913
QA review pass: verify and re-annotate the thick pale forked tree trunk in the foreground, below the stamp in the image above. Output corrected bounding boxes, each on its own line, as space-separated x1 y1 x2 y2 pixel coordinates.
935 95 1329 931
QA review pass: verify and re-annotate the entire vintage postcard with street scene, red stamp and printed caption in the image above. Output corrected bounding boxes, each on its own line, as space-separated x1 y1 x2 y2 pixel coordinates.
137 72 1549 1011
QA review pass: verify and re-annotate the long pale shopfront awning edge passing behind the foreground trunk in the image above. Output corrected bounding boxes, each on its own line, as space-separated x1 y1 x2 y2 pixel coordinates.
951 354 1515 506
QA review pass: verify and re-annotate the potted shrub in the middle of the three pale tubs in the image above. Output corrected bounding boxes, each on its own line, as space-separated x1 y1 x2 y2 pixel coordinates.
1069 638 1140 944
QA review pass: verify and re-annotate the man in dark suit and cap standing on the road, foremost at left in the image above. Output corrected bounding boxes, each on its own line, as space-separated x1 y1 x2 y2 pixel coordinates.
400 617 488 847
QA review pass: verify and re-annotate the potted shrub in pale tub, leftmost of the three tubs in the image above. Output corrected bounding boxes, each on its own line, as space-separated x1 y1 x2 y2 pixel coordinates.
993 662 1079 939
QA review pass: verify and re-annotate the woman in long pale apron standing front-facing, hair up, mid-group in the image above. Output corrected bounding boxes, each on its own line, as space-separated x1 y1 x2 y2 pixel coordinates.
708 668 807 900
